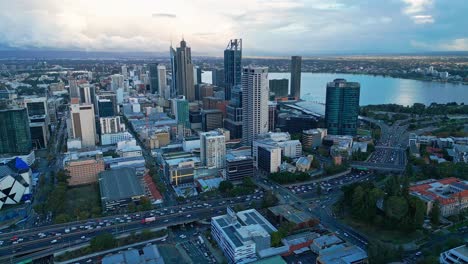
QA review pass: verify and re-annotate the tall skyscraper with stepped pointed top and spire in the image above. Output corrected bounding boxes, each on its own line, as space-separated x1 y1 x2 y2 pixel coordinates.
175 39 195 102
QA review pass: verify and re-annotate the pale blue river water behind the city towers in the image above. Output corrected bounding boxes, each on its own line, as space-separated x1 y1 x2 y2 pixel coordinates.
202 71 468 105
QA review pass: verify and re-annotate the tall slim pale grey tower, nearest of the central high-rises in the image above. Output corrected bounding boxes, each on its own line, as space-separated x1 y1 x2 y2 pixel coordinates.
242 66 268 145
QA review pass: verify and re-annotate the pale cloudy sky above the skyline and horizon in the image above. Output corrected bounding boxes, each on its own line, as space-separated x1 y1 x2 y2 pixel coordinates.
0 0 468 56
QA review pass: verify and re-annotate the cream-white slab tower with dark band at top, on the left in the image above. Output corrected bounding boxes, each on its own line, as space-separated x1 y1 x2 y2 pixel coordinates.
69 104 96 148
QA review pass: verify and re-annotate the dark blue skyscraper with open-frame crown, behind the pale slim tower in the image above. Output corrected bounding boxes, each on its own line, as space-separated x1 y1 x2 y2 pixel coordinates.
224 39 242 100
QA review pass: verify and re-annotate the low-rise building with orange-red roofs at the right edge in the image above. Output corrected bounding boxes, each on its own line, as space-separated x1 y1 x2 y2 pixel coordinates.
410 177 468 216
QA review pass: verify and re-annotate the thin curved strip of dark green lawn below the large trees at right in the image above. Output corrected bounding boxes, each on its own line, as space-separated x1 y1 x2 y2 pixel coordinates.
341 217 424 244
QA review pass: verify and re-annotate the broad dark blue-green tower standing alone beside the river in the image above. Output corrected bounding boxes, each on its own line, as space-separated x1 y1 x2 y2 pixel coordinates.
325 79 361 136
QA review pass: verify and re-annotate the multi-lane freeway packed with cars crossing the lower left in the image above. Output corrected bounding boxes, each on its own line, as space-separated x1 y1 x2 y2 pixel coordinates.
0 198 263 262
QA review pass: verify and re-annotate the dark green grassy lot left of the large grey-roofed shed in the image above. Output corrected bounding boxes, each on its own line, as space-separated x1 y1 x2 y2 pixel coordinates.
65 184 101 220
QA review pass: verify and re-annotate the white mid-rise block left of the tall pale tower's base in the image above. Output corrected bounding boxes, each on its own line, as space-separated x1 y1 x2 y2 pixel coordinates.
200 131 226 168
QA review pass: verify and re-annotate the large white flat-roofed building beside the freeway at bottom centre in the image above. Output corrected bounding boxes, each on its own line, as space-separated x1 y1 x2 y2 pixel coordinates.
211 207 277 263
